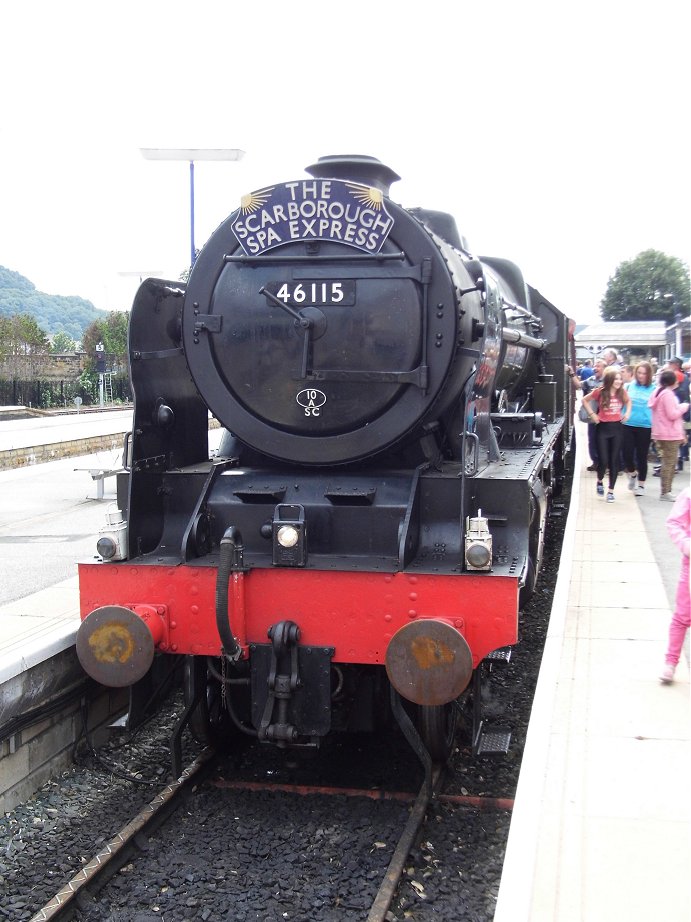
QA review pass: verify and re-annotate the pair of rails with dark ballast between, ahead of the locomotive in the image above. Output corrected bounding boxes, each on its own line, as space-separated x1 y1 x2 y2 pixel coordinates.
31 750 512 922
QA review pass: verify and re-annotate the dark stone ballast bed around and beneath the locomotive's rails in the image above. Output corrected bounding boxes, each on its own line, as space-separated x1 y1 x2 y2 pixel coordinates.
0 488 558 922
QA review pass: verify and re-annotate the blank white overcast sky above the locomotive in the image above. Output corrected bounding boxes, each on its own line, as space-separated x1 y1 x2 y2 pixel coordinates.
0 0 691 323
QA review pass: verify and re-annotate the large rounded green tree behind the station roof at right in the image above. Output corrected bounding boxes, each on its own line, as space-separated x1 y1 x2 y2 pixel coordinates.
600 250 691 323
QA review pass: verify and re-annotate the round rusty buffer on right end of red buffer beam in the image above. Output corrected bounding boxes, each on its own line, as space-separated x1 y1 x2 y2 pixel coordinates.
386 619 473 706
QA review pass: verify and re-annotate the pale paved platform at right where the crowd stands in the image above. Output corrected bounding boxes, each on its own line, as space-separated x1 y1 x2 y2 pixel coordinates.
494 423 691 922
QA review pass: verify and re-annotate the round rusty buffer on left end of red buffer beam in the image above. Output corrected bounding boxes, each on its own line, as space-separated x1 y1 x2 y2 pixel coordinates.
77 605 164 688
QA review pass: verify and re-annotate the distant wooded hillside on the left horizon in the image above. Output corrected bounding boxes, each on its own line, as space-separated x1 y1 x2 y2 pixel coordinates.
0 266 106 342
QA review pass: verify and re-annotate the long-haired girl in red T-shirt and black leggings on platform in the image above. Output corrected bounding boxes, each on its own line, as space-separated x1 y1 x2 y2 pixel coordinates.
583 368 631 503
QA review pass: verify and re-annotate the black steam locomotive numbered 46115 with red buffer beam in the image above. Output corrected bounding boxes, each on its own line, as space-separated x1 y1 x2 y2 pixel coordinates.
77 156 573 761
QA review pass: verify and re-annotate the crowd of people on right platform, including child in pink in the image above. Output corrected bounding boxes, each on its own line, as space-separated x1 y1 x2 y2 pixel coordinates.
568 349 691 685
